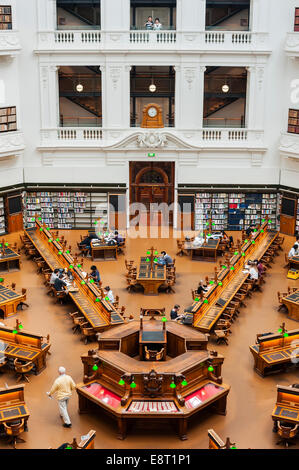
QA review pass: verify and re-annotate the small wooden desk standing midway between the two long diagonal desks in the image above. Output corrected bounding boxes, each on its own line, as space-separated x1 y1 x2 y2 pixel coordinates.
136 257 166 295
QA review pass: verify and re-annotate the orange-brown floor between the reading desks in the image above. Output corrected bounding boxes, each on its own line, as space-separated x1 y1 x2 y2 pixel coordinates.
0 231 299 449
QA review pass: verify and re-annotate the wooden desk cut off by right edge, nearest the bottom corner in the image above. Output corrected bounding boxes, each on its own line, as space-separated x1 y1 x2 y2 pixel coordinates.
272 385 299 432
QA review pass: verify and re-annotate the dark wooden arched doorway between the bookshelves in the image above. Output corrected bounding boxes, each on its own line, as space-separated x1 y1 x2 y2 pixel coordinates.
130 162 174 225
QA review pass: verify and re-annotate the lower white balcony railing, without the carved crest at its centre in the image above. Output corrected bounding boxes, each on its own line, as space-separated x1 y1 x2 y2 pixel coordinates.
40 127 266 151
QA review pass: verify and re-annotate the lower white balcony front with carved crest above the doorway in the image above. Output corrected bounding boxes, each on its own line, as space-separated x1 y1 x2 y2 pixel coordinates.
39 127 266 152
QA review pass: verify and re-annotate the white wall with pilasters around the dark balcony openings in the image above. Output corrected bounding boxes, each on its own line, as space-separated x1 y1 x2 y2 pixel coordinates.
0 0 299 192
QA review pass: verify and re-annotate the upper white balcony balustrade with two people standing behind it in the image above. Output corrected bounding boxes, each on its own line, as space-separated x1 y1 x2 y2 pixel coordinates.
36 30 270 54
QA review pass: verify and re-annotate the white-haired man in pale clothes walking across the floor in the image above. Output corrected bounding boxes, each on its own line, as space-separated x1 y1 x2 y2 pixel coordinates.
47 367 76 428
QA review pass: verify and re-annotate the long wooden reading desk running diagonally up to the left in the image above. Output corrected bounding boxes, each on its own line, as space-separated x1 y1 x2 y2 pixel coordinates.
26 220 124 331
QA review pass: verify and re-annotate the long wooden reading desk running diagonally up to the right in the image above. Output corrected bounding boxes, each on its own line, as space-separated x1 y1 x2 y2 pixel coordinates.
190 221 278 333
